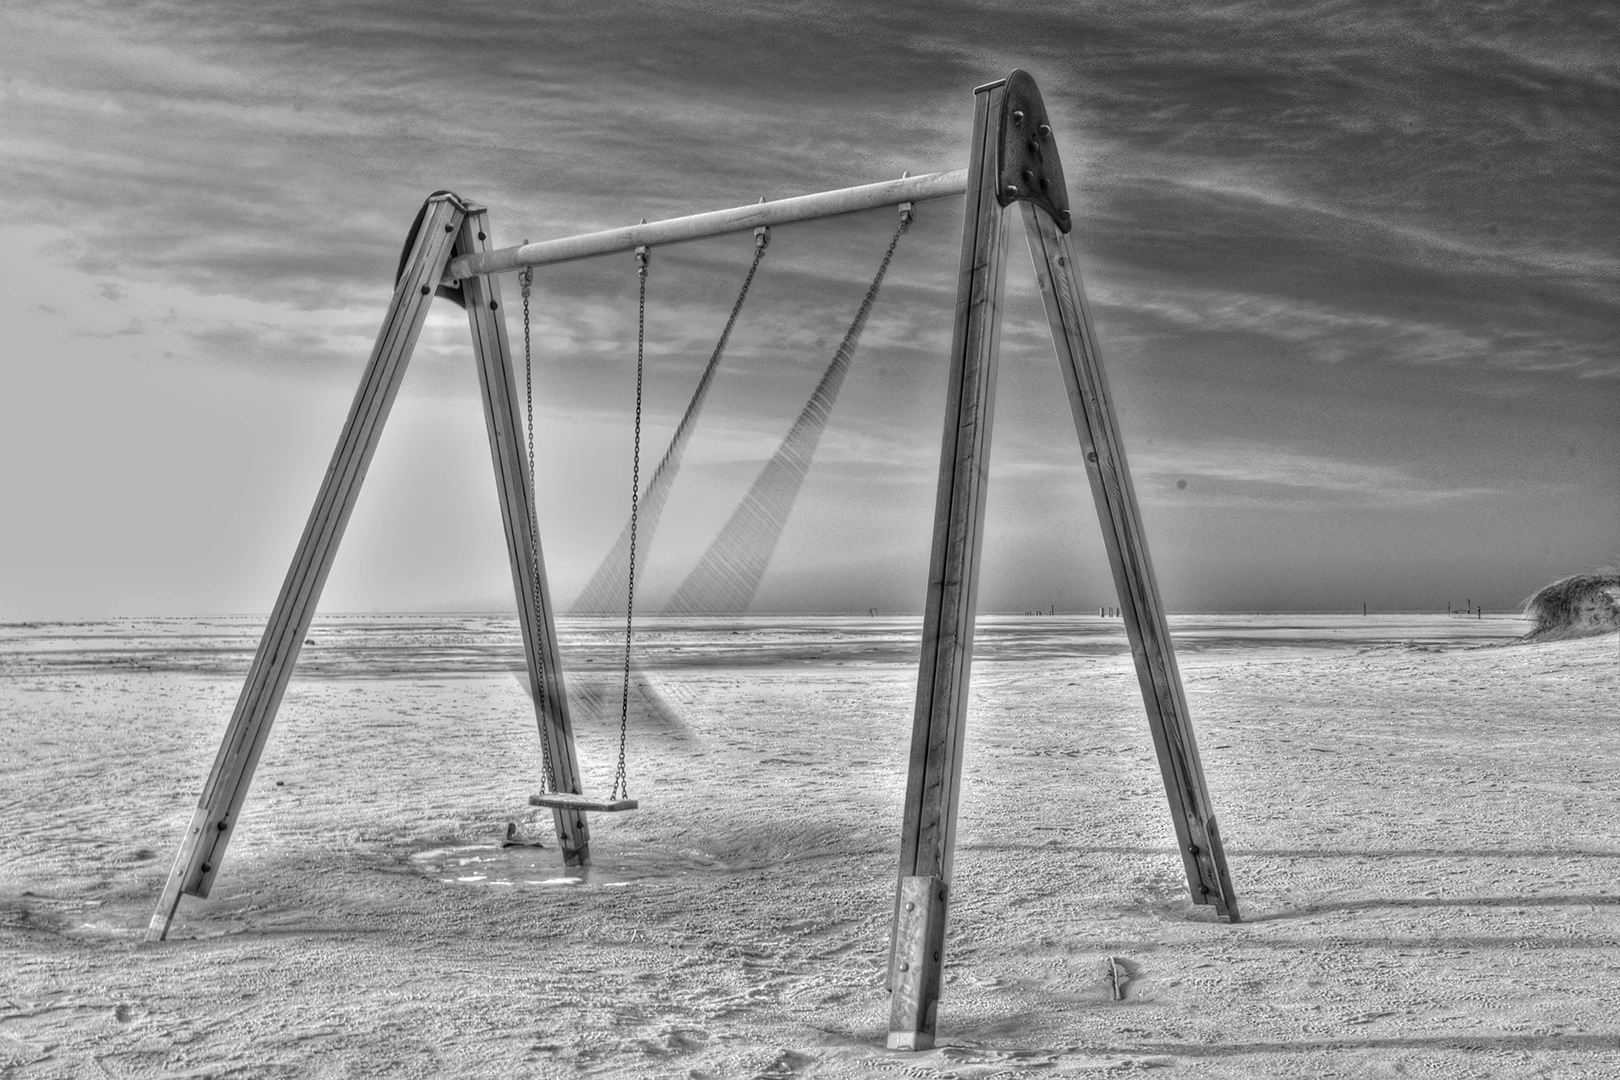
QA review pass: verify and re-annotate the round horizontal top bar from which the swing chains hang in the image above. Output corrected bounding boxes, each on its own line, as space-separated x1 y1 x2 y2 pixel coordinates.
446 168 967 282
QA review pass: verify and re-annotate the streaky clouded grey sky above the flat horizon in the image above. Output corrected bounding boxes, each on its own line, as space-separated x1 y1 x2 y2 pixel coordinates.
0 0 1620 620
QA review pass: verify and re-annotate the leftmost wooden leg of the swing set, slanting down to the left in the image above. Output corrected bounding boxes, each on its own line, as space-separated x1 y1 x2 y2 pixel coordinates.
146 194 465 941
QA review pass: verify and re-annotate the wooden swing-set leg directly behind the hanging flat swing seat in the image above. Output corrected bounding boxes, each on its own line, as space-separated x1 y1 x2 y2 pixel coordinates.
457 207 591 866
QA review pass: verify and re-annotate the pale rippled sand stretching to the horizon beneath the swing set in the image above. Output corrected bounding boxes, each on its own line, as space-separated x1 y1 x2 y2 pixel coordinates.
0 615 1620 1078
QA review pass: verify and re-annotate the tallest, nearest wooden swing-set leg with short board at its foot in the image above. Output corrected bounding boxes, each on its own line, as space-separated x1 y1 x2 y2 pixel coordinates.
888 83 1006 1049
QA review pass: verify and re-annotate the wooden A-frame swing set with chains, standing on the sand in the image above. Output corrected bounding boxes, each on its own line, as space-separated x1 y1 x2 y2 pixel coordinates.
147 71 1238 1049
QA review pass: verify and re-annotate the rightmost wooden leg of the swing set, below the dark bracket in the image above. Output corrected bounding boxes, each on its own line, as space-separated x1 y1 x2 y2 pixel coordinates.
1019 202 1238 923
